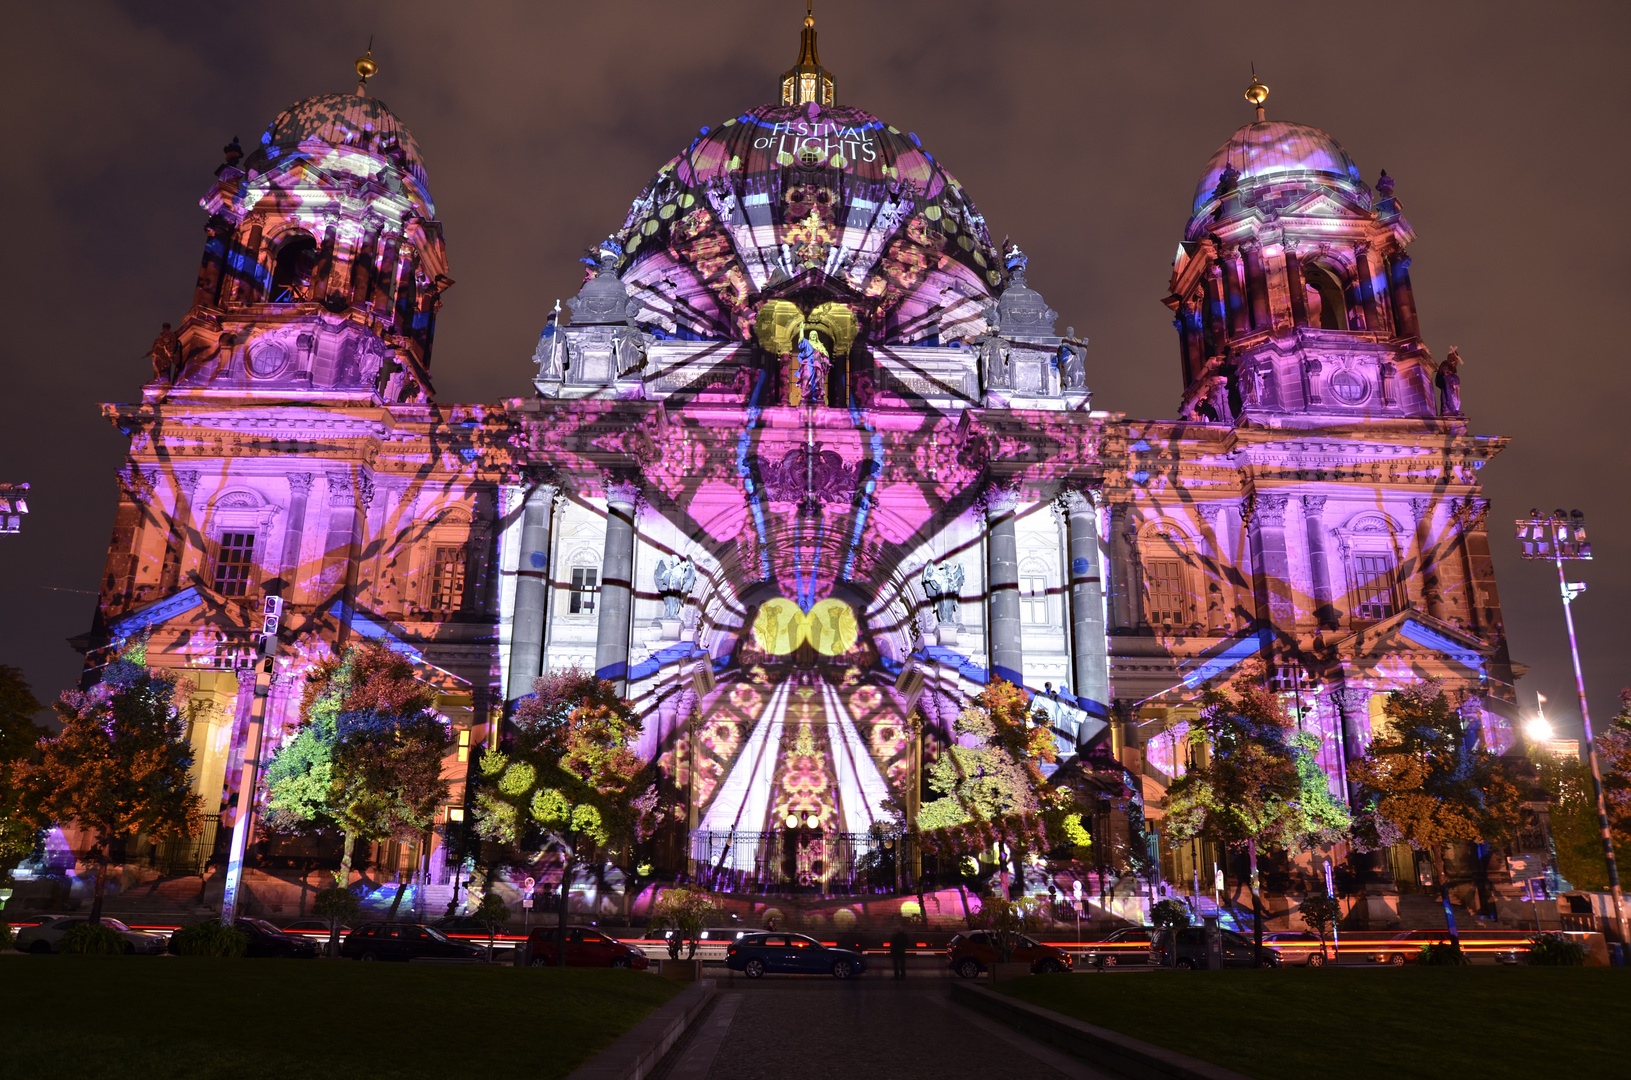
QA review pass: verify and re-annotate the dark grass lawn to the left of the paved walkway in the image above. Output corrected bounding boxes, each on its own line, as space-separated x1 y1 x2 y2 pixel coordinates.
0 954 680 1080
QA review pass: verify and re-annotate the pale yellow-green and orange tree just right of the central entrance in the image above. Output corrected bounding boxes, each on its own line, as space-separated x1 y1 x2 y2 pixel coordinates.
912 679 1056 896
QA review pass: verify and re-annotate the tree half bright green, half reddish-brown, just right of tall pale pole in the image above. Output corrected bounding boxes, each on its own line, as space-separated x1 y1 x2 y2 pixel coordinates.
266 641 450 912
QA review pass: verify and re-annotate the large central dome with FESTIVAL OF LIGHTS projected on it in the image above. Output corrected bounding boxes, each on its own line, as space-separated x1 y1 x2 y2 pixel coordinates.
608 101 1003 343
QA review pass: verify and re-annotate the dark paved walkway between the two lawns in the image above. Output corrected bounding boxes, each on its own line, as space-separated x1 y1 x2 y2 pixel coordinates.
657 969 1112 1080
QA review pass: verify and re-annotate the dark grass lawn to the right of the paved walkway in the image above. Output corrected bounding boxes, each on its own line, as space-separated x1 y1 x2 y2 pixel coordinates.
998 966 1631 1080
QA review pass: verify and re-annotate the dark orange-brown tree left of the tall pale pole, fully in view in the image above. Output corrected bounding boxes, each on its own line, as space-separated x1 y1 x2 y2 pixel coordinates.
18 641 204 925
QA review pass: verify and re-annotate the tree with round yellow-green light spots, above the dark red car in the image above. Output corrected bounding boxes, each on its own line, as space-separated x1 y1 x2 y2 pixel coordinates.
473 671 659 964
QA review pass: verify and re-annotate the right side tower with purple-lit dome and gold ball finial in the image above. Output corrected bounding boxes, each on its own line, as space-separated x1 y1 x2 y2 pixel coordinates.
1166 80 1435 426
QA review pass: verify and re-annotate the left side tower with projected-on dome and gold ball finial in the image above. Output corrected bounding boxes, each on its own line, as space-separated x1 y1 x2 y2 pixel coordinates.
163 57 453 401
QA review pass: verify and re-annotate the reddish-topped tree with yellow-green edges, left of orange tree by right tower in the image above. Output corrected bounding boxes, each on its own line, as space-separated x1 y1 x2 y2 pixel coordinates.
1166 672 1350 946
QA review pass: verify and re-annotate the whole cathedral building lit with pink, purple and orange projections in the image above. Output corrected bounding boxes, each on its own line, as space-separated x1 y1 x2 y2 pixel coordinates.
83 23 1515 892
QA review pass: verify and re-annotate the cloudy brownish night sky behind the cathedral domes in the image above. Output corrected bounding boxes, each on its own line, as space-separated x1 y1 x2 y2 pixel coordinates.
0 0 1631 734
